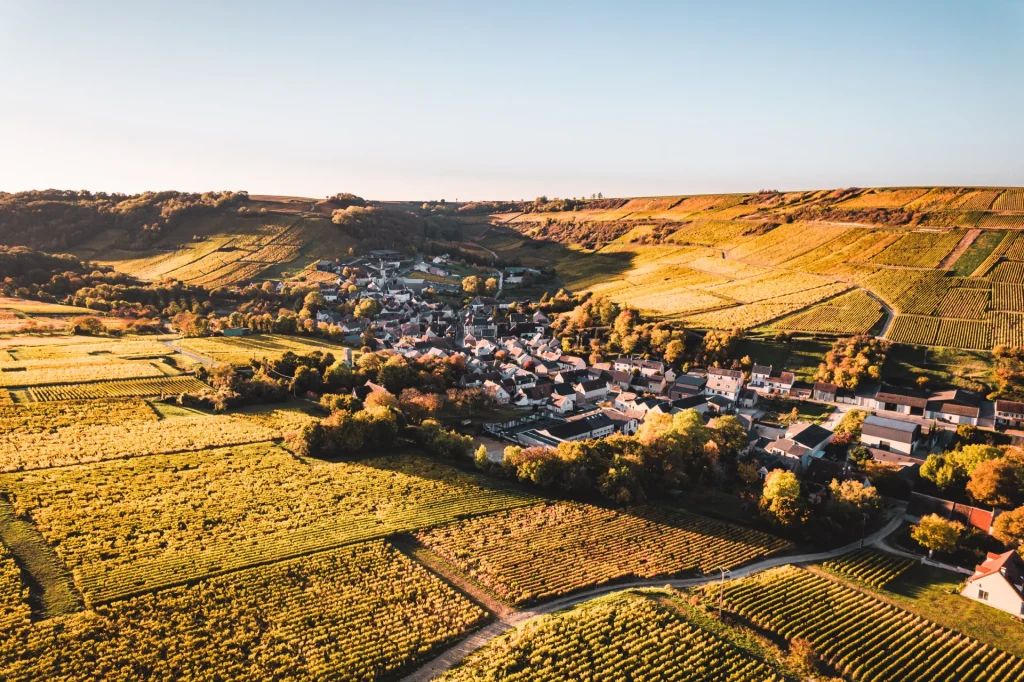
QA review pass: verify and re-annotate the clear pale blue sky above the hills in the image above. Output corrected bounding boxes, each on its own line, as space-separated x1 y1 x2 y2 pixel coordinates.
0 0 1024 201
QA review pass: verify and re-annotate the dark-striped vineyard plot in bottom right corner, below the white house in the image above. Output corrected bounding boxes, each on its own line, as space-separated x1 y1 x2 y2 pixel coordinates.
706 566 1024 682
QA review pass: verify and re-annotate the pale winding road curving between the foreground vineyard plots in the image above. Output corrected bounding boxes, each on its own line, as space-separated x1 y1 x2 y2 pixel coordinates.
402 508 903 682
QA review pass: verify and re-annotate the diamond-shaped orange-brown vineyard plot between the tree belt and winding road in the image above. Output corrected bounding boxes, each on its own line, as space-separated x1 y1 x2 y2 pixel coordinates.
417 503 788 604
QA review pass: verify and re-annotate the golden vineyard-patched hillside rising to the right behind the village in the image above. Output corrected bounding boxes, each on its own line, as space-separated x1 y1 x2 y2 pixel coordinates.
475 187 1024 350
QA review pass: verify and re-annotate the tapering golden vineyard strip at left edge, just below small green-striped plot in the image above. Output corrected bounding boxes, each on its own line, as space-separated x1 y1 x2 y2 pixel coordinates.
0 411 280 471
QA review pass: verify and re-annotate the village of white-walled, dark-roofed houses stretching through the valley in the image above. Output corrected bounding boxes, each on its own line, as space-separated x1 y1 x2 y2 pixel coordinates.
228 245 1024 613
